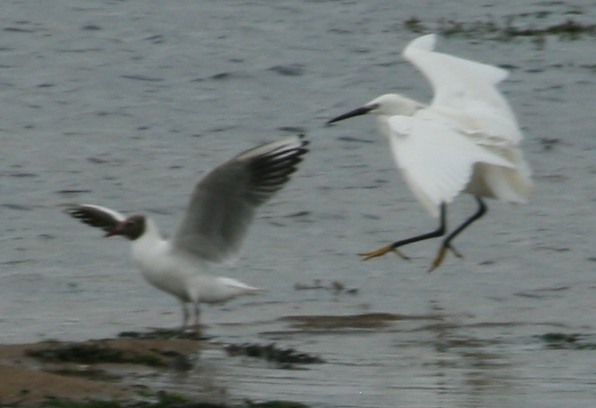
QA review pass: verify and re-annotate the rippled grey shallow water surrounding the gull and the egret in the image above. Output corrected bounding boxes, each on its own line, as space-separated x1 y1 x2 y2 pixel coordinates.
0 0 596 407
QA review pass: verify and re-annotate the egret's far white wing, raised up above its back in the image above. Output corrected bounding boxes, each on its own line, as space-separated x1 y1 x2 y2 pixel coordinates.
403 34 523 145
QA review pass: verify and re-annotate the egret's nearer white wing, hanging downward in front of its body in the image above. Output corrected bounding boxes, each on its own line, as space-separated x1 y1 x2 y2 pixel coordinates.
388 116 514 217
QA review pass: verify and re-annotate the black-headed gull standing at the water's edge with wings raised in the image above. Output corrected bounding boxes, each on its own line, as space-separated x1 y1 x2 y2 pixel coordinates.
64 135 308 329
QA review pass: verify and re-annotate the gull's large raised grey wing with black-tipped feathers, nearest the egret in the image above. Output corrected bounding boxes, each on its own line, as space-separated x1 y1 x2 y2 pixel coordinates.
173 135 308 262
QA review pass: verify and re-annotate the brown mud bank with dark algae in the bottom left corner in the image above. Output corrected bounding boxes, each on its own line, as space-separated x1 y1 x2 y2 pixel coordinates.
0 339 200 407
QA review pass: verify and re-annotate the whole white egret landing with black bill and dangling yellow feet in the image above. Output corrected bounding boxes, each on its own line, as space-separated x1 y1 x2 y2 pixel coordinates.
329 34 532 269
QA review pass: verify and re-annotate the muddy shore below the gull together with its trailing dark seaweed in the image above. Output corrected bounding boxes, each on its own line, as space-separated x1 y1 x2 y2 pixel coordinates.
0 330 324 407
